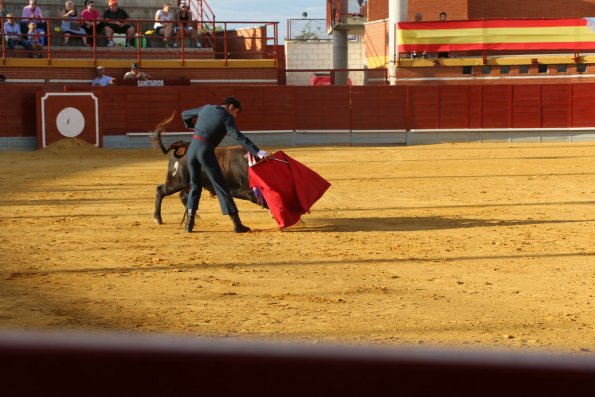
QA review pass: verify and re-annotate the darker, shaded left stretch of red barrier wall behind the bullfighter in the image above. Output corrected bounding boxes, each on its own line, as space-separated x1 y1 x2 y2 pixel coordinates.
0 85 406 137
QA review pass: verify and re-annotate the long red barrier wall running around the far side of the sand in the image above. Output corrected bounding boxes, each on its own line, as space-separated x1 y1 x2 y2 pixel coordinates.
5 83 595 141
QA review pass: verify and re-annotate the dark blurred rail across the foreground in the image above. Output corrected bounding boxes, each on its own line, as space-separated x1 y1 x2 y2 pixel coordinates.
0 333 595 397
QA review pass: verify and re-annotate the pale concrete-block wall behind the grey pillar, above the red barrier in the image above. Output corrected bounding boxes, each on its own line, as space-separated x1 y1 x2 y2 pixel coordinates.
285 41 365 85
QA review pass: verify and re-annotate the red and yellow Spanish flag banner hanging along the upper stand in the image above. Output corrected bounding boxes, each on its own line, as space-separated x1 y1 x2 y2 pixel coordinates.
397 18 595 52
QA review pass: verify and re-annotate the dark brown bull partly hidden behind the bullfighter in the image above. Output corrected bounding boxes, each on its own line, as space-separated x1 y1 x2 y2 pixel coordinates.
151 117 267 224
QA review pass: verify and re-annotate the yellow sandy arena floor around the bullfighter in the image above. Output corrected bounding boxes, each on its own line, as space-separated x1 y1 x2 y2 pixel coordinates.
0 140 595 355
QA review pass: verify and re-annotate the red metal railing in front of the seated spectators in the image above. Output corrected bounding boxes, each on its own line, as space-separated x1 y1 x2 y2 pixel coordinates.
0 16 278 64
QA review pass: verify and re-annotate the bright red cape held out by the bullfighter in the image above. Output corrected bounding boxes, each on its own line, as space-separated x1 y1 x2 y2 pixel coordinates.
248 151 331 229
